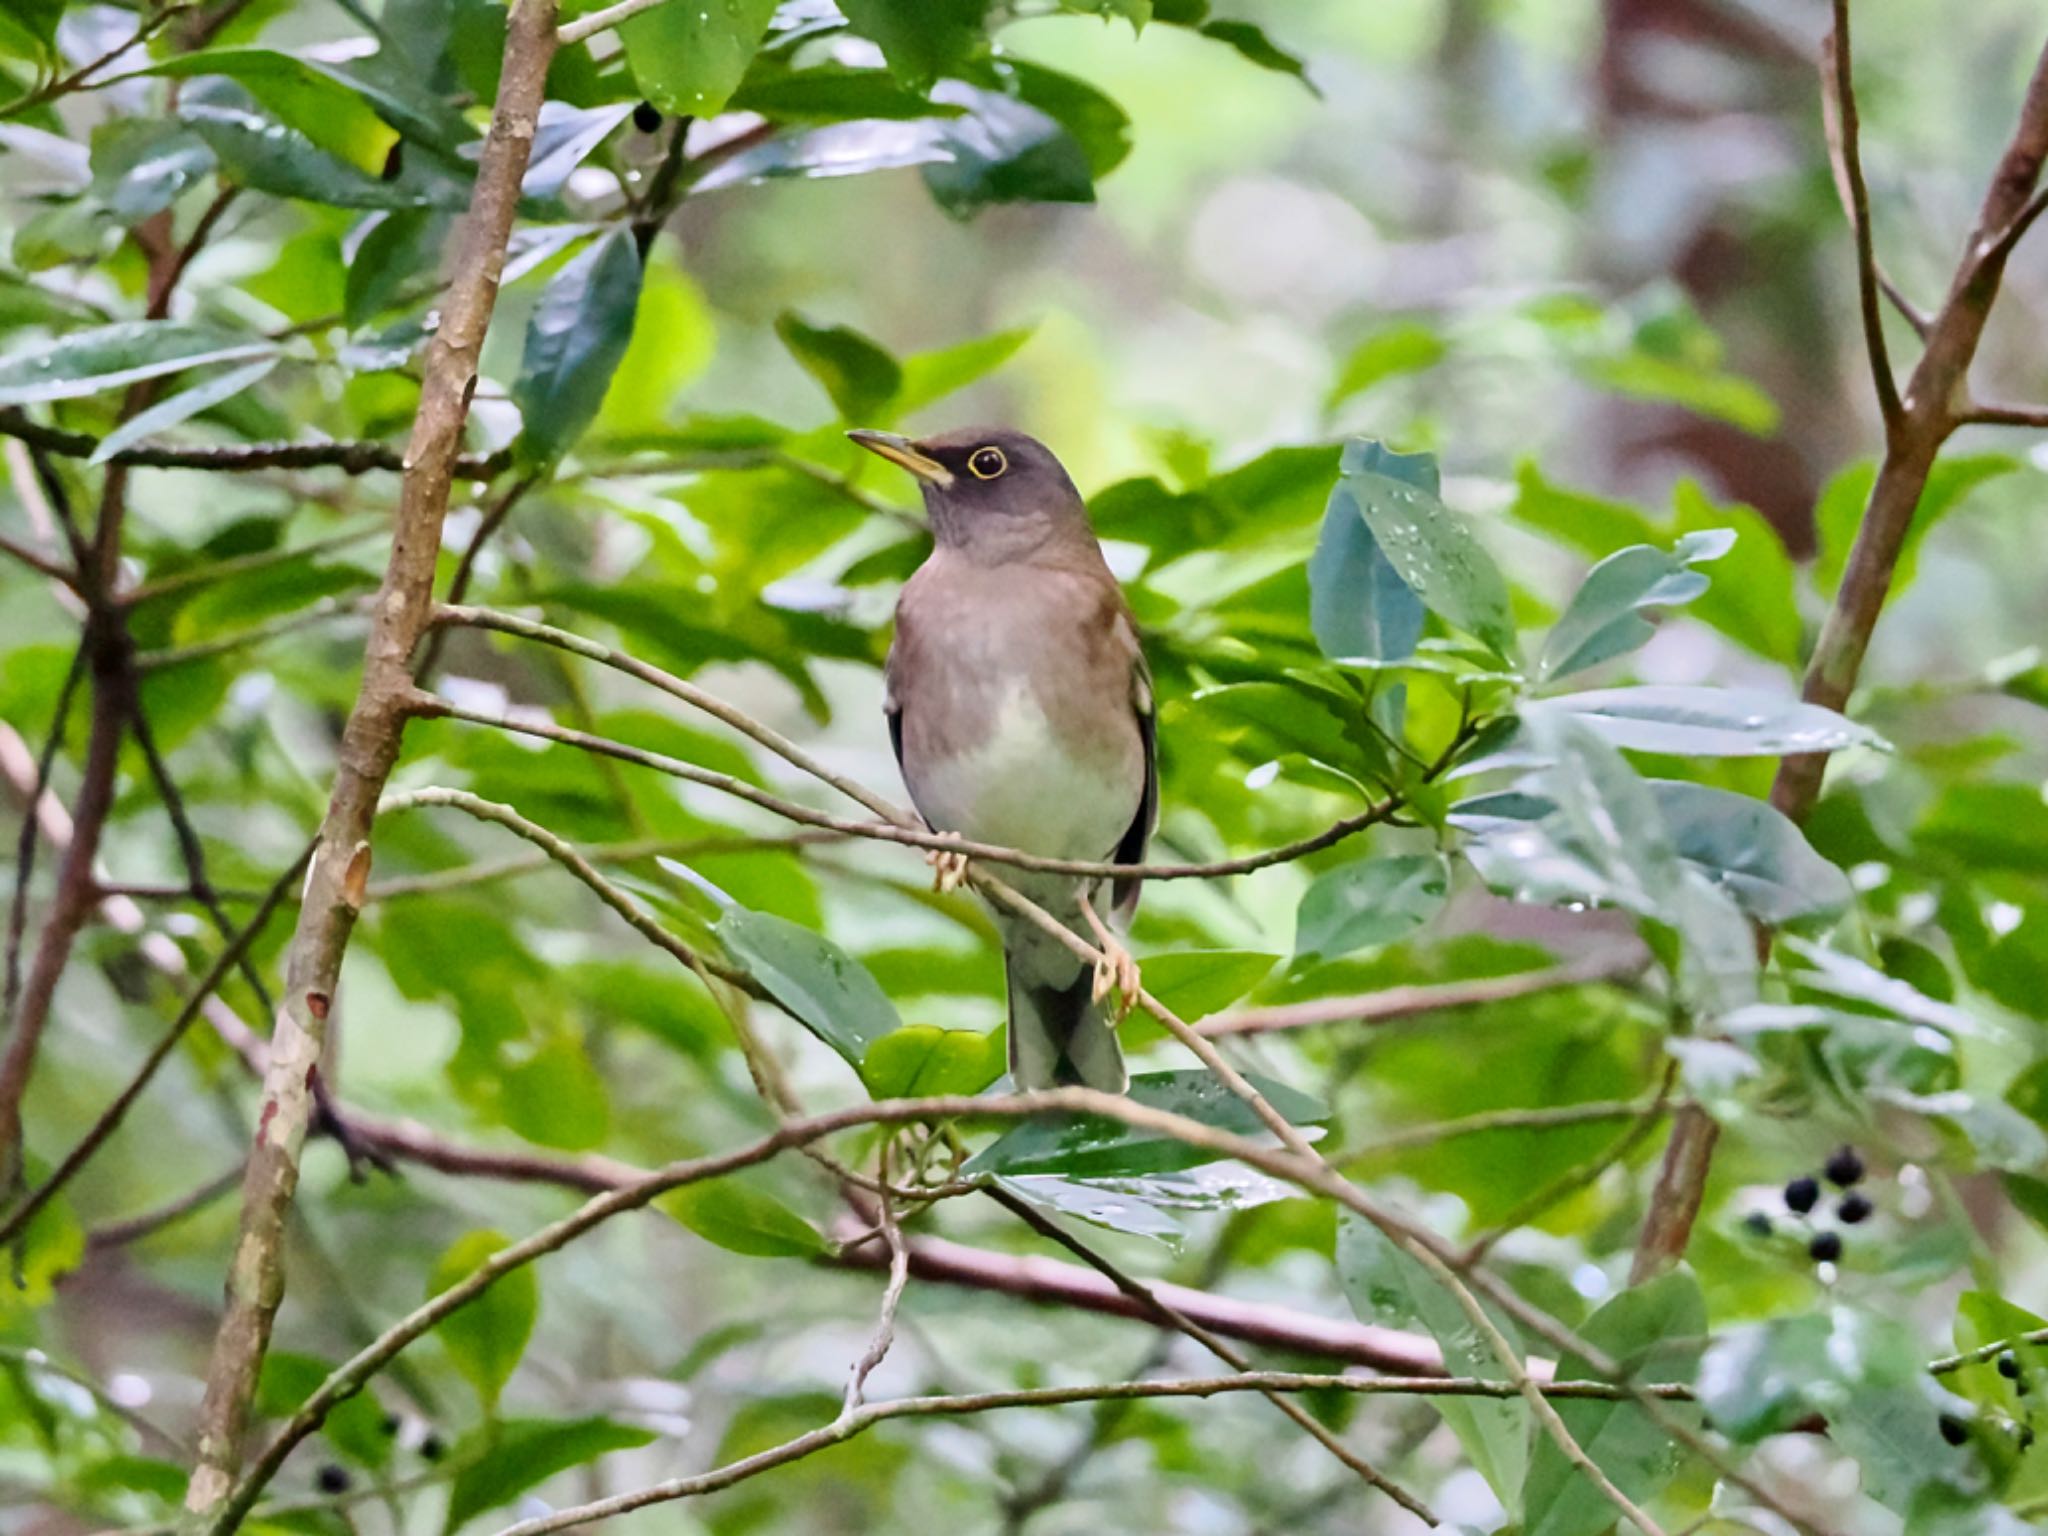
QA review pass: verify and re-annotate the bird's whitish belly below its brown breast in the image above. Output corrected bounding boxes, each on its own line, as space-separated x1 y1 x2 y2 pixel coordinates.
913 686 1143 858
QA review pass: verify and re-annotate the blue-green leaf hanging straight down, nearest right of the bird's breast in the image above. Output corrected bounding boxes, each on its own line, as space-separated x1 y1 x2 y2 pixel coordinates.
1309 442 1438 662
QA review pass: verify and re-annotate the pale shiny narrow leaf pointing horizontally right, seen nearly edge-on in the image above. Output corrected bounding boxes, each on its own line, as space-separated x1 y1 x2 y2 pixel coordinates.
1538 684 1886 758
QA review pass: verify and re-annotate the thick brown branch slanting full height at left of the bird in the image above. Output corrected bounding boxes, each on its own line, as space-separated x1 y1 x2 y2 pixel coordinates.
186 0 555 1522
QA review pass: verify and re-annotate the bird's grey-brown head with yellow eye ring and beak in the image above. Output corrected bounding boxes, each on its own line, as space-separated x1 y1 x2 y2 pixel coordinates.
846 426 1094 565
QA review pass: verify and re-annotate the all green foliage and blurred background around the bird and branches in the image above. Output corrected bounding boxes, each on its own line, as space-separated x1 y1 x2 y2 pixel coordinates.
0 0 2048 1536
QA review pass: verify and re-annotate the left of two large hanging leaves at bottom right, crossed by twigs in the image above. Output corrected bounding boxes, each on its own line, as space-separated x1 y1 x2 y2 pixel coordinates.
1337 1210 1528 1513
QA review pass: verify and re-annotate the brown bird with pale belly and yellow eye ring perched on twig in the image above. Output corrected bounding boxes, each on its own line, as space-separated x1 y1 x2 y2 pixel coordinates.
848 426 1159 1094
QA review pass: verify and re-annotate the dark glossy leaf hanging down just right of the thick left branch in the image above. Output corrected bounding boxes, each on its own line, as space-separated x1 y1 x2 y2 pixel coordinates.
512 227 641 465
